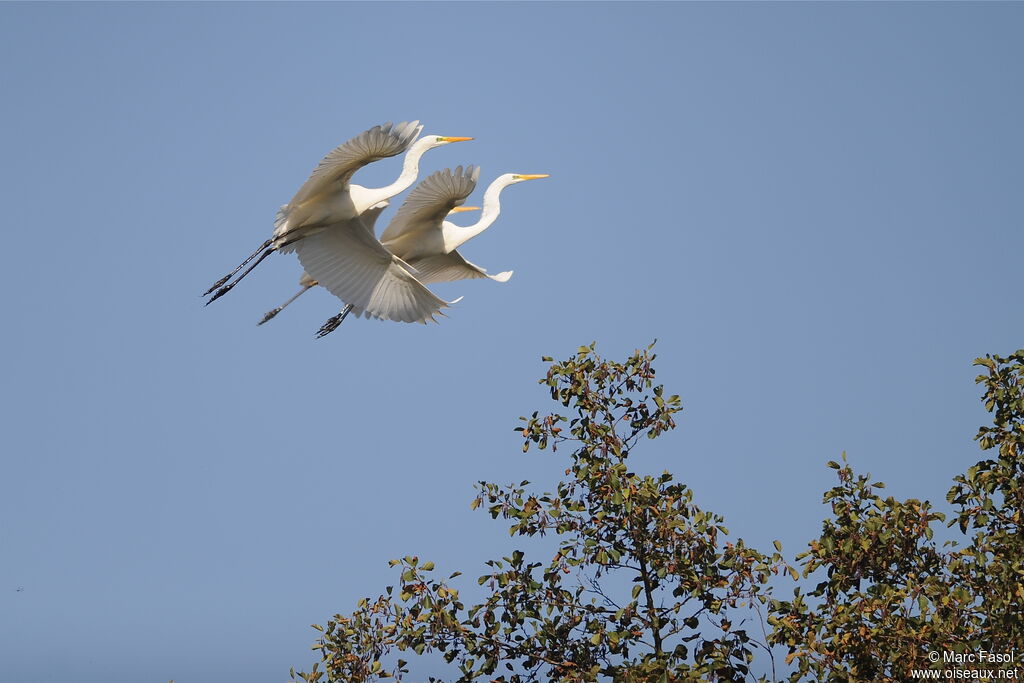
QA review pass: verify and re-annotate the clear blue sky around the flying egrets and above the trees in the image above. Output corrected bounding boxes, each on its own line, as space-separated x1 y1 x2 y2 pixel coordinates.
0 3 1024 683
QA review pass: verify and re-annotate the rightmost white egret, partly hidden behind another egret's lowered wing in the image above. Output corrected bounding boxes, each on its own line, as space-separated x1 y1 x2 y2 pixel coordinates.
313 166 549 337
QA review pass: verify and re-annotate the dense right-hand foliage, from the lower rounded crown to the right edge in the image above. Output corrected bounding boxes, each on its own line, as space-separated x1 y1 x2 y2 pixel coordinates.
769 351 1024 681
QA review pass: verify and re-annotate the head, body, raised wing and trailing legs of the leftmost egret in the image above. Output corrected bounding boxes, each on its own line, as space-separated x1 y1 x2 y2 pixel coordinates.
204 121 473 305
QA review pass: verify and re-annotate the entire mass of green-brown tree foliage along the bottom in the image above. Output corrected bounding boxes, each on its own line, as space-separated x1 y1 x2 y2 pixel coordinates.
292 345 1024 683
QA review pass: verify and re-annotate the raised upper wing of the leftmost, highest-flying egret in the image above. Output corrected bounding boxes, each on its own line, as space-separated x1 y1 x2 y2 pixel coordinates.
288 121 423 207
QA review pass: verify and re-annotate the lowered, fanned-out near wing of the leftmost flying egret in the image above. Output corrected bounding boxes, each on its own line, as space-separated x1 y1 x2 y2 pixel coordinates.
295 219 449 323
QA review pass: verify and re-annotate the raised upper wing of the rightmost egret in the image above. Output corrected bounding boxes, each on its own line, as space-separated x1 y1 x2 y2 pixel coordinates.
381 166 480 248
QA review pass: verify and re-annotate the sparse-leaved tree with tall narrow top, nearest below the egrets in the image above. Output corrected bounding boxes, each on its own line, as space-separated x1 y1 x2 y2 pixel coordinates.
293 345 784 683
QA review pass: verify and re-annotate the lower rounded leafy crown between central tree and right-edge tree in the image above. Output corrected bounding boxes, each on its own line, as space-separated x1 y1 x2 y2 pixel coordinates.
769 454 957 681
